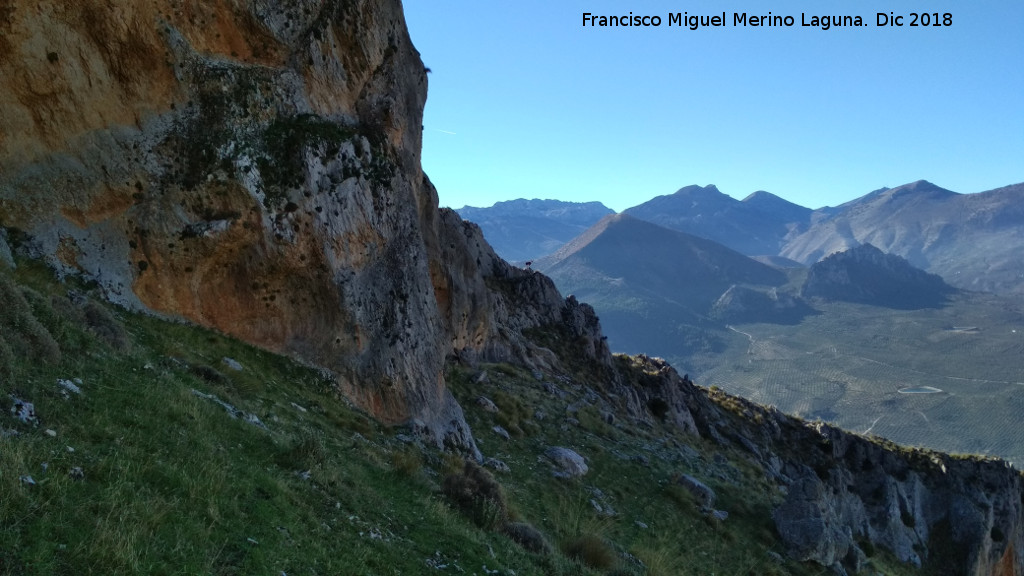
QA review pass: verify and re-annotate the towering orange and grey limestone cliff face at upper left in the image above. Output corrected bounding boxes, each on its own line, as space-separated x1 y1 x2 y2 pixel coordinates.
0 0 606 455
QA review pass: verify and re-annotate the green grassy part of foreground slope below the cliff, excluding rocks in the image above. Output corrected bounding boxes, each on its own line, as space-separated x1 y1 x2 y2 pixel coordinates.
0 258 917 575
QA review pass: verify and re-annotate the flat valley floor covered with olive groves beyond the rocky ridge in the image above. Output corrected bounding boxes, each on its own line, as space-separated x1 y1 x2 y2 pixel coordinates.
692 293 1024 464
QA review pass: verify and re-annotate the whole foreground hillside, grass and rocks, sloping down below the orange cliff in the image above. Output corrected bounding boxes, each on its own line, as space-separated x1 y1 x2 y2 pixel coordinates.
0 251 1022 576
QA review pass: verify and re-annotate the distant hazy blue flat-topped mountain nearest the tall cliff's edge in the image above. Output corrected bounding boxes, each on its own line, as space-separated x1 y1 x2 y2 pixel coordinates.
456 199 614 262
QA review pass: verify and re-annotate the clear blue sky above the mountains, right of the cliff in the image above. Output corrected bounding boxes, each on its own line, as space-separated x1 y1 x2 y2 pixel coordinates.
404 0 1024 210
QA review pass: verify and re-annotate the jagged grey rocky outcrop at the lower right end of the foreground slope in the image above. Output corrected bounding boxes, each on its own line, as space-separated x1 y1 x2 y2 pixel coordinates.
691 381 1024 576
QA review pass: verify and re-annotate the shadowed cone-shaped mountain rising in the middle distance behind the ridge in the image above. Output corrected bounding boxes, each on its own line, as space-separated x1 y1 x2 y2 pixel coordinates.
535 214 786 357
